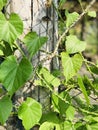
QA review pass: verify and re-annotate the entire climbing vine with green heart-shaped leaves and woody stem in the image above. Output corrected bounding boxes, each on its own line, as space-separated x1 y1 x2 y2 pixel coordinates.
0 0 98 130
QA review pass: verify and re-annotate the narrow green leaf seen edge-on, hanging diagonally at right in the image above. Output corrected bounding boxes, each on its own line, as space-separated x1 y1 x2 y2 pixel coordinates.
78 76 90 105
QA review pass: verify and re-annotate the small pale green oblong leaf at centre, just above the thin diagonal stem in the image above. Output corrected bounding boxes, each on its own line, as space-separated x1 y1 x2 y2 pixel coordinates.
40 68 60 87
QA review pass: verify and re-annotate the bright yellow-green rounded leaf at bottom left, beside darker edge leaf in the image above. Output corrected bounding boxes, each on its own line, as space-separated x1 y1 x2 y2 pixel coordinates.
18 98 42 130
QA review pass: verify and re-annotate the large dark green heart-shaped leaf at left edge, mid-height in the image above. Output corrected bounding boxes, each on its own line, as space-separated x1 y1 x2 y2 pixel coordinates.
0 56 32 94
